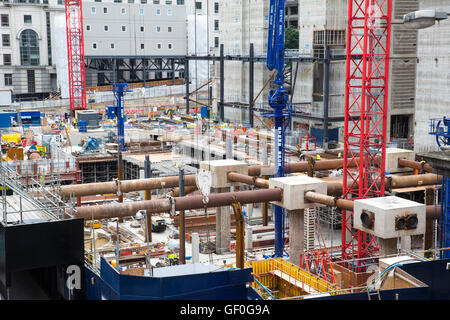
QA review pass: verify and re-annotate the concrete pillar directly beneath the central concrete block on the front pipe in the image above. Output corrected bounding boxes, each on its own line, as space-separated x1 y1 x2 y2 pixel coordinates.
289 209 305 266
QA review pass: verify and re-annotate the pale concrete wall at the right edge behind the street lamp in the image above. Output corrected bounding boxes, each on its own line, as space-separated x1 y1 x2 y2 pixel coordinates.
414 0 450 152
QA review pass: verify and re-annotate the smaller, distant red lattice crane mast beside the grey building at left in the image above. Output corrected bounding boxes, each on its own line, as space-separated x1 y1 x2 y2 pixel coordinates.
65 0 86 114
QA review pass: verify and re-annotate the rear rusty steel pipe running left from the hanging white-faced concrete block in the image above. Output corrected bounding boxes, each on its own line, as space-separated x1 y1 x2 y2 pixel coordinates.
61 174 196 198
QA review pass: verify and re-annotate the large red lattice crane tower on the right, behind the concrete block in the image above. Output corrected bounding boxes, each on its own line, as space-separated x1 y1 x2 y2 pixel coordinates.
342 0 392 272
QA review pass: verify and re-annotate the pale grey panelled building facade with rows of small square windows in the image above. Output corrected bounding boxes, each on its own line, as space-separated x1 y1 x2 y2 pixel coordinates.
83 1 186 56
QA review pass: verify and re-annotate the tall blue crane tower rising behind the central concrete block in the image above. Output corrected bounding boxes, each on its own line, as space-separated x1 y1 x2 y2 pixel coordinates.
264 0 291 257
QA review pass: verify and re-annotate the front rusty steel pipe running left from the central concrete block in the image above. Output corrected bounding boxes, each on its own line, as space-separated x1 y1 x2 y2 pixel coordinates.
75 188 283 219
